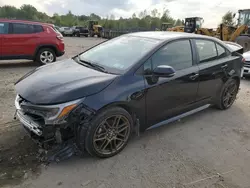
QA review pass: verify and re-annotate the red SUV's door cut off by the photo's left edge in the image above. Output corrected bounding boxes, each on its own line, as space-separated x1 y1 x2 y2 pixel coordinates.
0 22 10 59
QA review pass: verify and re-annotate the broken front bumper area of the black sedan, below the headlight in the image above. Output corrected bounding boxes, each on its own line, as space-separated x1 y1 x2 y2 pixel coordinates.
15 96 94 161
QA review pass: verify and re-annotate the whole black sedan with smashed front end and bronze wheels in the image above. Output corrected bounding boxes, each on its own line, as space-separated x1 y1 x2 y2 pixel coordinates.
15 32 243 160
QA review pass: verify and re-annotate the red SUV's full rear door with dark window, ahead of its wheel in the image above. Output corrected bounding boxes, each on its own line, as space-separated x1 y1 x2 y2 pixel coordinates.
8 23 39 58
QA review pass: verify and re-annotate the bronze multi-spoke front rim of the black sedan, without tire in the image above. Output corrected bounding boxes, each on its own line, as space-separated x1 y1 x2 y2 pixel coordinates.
93 115 131 155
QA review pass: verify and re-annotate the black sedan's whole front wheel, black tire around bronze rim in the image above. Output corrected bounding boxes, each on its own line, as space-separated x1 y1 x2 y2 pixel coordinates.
84 107 133 158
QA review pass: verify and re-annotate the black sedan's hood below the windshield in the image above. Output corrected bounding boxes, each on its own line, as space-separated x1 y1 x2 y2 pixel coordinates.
15 59 117 104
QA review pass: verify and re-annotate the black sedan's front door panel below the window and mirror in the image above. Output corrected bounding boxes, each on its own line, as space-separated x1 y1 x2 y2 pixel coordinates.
145 66 199 125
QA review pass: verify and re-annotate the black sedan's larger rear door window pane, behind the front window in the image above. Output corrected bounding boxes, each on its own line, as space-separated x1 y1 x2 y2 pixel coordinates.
195 40 217 63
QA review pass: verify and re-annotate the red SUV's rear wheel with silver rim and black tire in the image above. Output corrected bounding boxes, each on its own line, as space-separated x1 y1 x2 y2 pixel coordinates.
36 48 56 65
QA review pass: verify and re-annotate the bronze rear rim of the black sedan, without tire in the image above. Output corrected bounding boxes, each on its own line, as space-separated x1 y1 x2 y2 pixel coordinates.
222 80 238 108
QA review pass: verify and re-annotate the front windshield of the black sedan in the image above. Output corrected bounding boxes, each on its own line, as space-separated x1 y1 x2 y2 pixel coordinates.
79 36 160 74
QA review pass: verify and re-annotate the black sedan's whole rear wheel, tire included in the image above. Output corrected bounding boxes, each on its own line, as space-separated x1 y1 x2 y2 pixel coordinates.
215 79 239 110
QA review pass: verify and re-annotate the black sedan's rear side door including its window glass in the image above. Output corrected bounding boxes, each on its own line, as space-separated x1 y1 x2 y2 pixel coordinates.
193 39 237 101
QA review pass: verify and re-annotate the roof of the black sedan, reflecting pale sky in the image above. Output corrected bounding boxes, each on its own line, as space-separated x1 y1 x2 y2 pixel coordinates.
126 31 216 41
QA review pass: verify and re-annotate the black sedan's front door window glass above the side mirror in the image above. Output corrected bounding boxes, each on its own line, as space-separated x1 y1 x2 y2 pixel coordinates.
152 40 193 70
